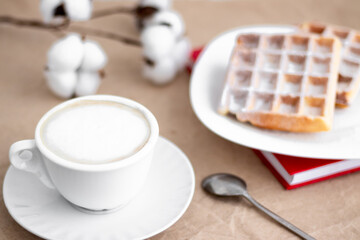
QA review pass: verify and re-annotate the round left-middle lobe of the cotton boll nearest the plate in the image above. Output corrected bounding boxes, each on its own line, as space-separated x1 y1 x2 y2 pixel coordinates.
140 25 175 61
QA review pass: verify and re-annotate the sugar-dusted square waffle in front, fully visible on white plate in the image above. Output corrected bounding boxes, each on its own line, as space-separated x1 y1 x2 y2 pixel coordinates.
218 34 341 132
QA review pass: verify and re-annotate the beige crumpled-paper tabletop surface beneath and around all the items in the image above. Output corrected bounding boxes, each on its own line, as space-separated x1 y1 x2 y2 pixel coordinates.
0 0 360 240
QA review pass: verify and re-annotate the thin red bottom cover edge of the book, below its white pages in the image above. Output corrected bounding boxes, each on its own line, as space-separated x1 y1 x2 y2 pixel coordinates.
253 149 360 190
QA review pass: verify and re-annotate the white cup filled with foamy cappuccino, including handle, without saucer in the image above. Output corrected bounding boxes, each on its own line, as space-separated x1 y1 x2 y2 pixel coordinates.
9 95 159 213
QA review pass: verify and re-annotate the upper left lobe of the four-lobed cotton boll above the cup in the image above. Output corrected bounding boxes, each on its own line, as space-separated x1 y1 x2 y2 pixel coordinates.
47 33 84 71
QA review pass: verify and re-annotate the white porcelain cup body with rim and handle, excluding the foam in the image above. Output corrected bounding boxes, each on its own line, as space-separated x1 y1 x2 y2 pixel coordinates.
9 95 159 212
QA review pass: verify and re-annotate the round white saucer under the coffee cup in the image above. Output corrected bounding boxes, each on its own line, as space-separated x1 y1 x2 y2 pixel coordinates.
3 137 195 240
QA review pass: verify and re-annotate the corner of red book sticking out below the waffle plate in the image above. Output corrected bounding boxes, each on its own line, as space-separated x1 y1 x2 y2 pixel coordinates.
254 150 360 190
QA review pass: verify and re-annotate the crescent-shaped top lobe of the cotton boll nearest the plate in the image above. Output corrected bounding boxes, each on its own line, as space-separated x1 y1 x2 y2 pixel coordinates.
144 11 185 38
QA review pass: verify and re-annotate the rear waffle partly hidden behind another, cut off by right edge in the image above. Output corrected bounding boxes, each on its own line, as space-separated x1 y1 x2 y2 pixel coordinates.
301 23 360 107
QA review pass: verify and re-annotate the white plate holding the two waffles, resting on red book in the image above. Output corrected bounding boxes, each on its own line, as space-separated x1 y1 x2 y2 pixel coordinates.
190 25 360 159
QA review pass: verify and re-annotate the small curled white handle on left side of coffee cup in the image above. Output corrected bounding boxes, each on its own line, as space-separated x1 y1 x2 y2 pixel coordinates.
9 139 55 189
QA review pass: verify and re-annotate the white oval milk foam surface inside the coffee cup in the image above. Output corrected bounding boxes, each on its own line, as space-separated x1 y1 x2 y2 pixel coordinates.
41 101 150 164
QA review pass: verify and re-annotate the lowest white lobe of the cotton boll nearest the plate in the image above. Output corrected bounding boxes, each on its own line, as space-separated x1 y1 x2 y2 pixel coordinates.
143 58 176 85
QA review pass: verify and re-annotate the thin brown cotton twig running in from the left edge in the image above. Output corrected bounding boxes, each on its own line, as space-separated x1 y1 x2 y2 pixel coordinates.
0 16 141 46
